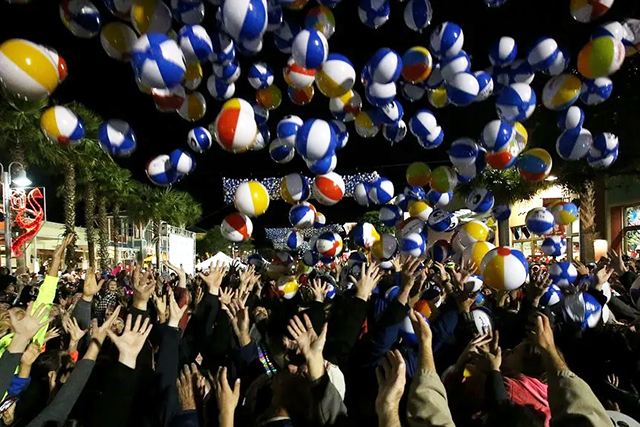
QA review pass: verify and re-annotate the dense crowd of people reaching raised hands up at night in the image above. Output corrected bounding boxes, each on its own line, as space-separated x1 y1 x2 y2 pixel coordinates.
0 237 640 427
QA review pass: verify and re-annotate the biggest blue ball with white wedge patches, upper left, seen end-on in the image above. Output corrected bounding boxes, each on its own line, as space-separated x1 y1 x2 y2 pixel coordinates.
131 33 186 89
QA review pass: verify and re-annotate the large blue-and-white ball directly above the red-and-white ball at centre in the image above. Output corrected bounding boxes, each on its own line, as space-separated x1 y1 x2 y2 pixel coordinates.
296 119 337 160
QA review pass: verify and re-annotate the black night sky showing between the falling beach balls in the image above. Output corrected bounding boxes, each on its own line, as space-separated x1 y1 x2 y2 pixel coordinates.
0 0 640 232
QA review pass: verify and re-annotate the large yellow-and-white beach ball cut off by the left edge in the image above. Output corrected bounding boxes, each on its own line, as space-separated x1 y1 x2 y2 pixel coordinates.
0 39 64 102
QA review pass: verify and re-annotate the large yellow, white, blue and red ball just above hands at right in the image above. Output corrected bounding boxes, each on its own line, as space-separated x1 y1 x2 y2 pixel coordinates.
480 246 529 291
